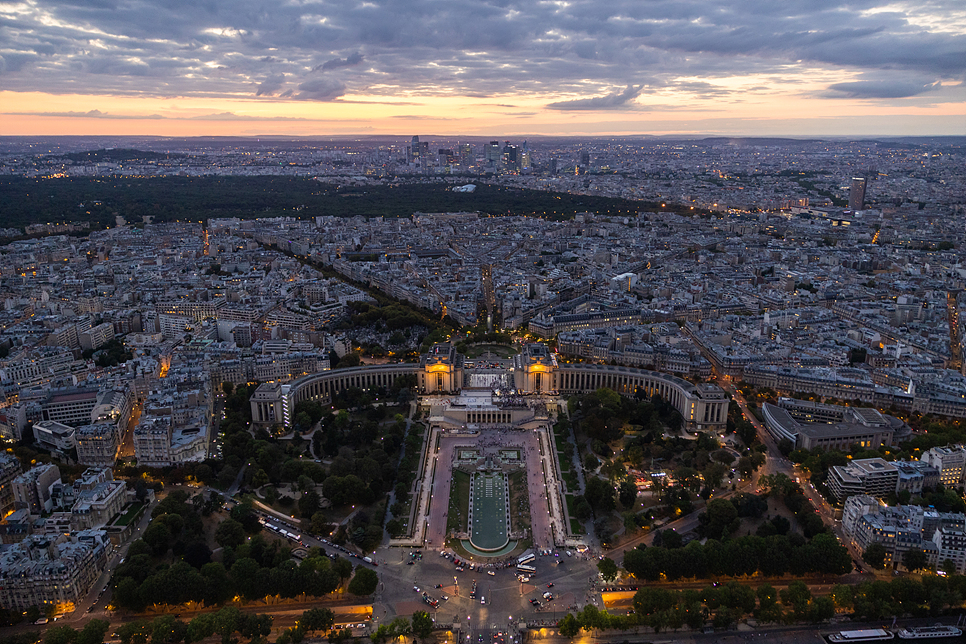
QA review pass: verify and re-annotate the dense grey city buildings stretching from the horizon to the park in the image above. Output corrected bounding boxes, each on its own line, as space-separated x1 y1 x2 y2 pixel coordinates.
0 137 966 607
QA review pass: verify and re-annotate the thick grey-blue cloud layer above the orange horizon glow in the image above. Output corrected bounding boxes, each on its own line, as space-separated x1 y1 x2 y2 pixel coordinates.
0 0 966 110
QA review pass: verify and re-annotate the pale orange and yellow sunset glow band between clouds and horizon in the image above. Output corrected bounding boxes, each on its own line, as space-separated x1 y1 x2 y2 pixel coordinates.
0 78 964 137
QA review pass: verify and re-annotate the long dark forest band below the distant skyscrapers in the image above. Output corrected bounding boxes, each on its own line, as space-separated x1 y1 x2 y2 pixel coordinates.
0 176 697 227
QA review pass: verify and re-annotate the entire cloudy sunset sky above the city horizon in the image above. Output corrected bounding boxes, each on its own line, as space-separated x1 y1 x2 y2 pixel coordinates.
0 0 966 136
